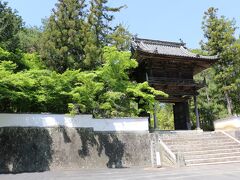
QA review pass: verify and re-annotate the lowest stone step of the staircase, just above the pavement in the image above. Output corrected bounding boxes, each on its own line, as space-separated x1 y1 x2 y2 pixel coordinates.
185 156 240 165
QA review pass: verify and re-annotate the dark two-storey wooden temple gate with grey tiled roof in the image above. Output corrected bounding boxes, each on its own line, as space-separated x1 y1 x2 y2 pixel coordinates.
131 38 218 130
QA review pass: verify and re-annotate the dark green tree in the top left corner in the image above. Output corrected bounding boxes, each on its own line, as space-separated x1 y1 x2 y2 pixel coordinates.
0 1 23 52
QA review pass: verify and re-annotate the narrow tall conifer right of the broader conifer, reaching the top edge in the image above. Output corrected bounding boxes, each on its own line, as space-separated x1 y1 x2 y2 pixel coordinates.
84 0 124 69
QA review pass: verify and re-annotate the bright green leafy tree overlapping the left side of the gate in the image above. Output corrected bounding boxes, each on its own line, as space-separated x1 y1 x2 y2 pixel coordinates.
70 47 166 117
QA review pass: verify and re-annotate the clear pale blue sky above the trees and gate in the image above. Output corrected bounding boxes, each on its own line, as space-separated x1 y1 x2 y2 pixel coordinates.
5 0 240 48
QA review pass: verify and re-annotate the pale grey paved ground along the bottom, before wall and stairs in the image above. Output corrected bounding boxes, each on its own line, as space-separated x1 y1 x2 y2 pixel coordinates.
0 163 240 180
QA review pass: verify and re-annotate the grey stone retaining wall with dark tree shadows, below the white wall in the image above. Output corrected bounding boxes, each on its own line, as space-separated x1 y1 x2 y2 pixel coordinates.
0 127 151 173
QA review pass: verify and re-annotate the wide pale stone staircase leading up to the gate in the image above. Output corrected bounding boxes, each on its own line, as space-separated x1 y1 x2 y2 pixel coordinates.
159 131 240 166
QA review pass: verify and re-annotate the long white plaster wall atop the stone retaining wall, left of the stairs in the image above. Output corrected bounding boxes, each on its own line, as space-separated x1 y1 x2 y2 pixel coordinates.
0 113 148 131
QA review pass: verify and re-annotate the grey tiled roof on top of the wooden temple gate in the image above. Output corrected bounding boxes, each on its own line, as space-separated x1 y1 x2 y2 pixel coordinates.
132 38 218 60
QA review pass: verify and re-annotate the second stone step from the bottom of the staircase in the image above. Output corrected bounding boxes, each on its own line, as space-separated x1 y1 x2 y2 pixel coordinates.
184 151 240 160
